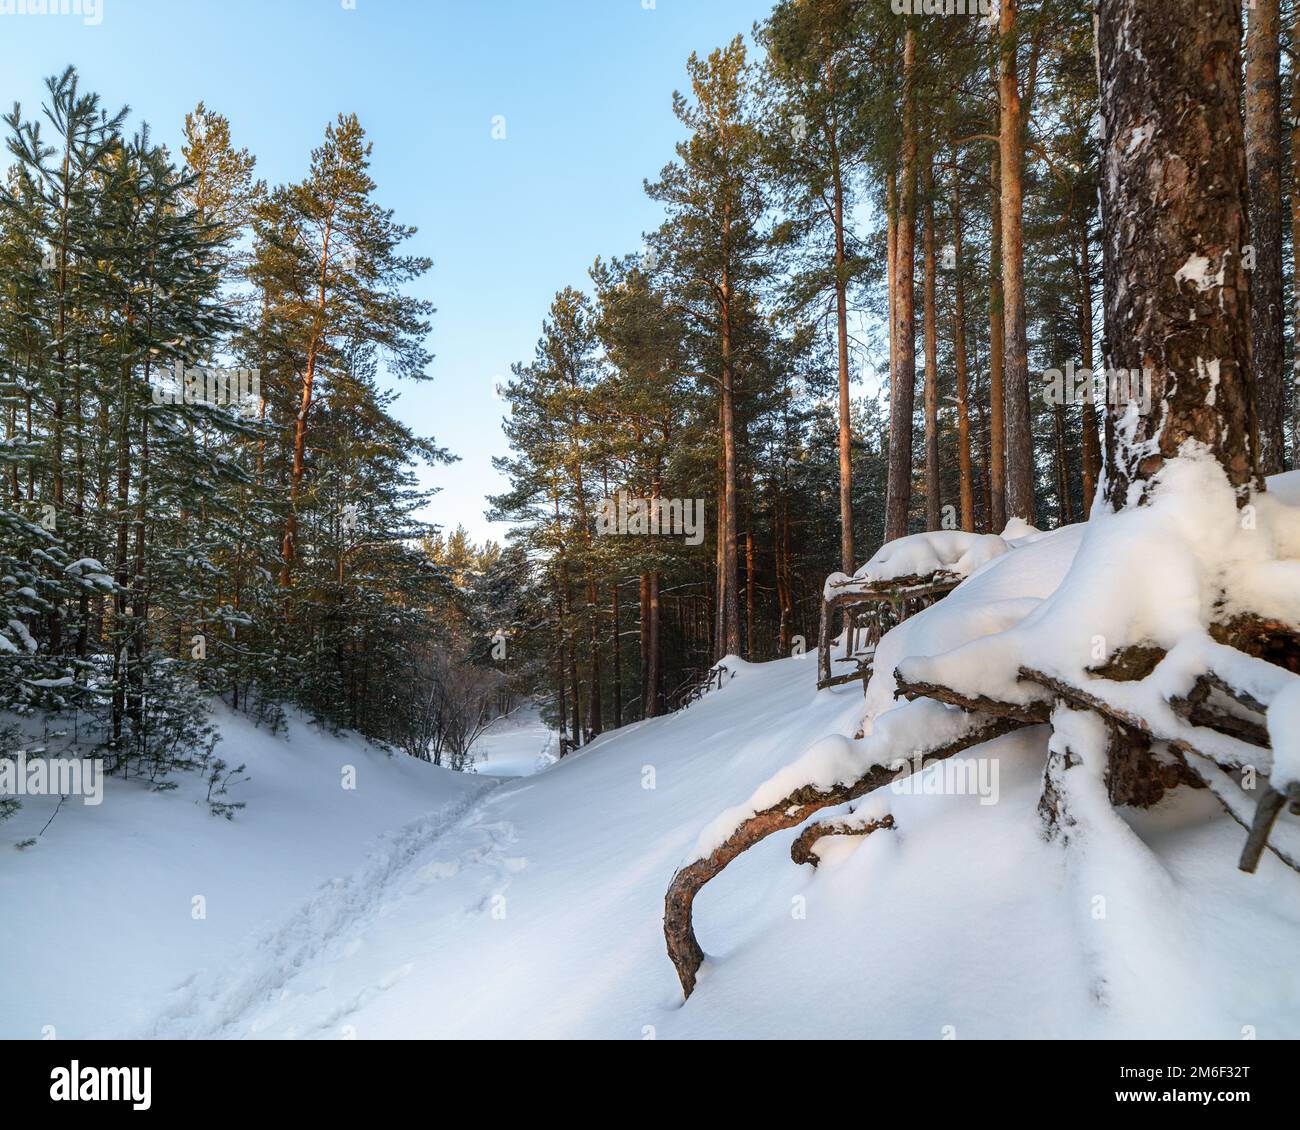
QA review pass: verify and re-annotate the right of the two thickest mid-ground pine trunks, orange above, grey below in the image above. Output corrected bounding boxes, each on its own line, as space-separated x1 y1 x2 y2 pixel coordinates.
997 0 1036 525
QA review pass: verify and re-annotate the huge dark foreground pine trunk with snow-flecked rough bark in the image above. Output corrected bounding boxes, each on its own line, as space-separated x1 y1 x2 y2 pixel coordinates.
1097 0 1262 510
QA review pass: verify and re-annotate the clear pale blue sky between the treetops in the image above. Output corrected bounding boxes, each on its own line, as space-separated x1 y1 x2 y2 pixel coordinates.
0 0 771 540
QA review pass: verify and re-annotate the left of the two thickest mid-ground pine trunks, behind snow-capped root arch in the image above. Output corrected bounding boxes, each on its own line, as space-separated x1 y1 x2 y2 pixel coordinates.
885 27 917 541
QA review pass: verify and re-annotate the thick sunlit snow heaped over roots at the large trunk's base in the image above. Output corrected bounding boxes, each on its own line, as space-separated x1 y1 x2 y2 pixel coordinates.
899 441 1300 722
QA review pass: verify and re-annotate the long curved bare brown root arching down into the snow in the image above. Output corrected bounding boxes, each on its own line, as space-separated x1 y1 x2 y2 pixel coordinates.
663 716 1027 997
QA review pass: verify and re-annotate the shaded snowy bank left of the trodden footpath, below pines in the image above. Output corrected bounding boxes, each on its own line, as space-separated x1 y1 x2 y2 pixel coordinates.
0 710 495 1039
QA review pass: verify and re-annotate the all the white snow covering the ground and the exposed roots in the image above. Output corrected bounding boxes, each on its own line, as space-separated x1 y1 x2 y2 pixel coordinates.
0 449 1300 1039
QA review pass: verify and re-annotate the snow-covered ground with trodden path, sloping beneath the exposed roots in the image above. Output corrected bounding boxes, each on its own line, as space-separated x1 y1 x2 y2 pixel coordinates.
0 603 1300 1039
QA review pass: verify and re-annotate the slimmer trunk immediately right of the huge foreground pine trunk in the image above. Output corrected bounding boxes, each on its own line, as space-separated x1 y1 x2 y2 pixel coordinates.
1245 0 1286 475
